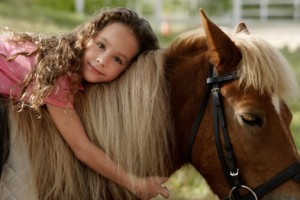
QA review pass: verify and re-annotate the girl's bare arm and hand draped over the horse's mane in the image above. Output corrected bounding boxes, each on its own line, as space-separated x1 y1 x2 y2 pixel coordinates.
46 104 169 199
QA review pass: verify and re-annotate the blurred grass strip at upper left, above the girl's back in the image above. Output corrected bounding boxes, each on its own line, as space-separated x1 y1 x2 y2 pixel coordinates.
0 1 86 33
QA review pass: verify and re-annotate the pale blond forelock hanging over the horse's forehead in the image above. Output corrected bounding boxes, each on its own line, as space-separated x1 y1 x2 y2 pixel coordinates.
231 33 299 98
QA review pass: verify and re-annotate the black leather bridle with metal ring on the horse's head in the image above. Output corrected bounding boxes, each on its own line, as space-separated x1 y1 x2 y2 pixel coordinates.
188 64 300 200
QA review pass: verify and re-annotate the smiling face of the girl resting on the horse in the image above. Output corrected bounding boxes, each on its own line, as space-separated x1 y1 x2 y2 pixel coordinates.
82 23 139 83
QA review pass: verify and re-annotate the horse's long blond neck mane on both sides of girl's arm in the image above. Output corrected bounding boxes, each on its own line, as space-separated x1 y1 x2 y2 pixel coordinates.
10 50 173 200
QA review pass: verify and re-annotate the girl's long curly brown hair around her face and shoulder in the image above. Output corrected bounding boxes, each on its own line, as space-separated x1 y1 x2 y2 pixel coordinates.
7 8 159 110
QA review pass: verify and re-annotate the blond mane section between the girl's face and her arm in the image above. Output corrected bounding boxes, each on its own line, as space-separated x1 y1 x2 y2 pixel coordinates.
77 50 172 176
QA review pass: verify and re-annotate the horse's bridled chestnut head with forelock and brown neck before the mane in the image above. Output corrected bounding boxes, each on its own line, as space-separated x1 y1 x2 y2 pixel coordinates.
166 9 300 199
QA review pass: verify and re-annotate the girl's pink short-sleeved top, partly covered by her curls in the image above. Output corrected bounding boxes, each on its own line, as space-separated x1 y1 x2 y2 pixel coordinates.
0 36 82 108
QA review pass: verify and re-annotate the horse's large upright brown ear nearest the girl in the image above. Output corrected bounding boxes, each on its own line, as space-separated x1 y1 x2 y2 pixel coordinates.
200 9 241 74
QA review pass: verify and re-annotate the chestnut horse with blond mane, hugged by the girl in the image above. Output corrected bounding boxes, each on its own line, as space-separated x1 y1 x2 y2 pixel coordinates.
0 11 300 200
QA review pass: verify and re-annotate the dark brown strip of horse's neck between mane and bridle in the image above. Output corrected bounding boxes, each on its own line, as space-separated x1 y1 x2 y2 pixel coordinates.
168 58 207 167
